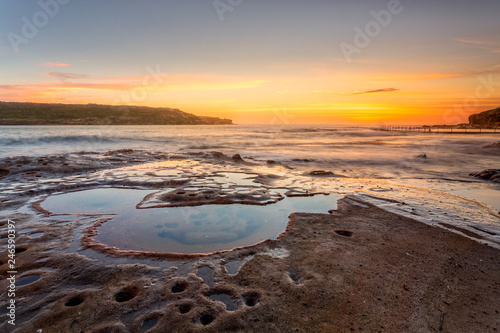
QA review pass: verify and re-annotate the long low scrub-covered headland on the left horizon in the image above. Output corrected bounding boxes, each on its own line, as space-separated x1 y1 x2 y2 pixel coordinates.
0 102 233 125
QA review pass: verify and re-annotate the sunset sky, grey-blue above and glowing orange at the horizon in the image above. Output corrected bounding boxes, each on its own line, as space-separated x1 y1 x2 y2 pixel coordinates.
0 0 500 125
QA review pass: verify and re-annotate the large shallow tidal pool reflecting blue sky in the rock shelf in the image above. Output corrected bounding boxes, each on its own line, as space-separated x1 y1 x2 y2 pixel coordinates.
42 188 342 254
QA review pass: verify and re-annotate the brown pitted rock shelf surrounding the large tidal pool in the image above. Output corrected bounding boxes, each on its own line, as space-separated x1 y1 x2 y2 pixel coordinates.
0 150 500 333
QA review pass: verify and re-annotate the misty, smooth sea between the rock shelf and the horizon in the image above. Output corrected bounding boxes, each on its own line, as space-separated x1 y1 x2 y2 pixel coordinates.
0 125 500 179
